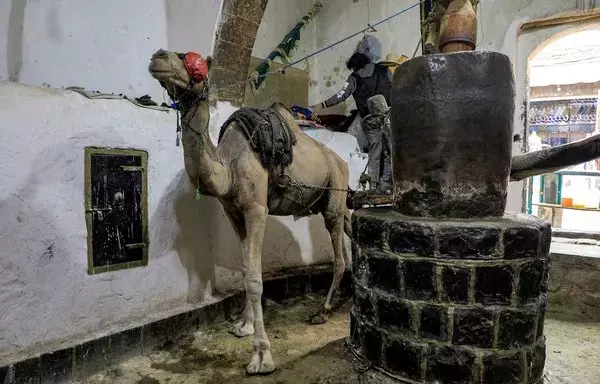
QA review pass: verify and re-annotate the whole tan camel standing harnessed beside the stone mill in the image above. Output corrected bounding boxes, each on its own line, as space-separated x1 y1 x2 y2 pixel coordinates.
148 49 351 374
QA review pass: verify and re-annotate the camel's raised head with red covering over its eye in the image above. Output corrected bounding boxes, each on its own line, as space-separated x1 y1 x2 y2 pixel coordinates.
148 49 212 101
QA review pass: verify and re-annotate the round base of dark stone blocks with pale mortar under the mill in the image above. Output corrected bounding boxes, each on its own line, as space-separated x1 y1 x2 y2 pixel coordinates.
351 208 551 384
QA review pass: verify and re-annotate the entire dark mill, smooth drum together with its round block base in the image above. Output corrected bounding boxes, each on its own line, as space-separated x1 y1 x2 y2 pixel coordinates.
351 52 551 384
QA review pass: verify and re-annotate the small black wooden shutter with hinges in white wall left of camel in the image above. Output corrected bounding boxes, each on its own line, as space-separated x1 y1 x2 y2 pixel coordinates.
85 148 148 274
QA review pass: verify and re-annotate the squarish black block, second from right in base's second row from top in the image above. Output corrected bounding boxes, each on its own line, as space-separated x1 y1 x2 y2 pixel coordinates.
475 266 513 305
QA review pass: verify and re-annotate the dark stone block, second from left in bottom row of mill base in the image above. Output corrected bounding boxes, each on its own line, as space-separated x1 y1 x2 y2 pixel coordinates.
384 339 425 382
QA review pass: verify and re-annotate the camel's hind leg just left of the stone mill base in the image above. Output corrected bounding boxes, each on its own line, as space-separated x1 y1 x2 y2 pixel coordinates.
311 214 347 324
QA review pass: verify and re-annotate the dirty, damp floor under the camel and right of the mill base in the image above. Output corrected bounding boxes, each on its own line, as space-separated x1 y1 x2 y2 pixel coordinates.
78 296 600 384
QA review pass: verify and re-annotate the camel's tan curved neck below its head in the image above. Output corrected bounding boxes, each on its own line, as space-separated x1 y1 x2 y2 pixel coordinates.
181 100 228 197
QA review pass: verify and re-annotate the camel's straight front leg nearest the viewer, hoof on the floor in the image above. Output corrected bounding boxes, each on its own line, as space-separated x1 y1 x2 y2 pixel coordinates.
242 206 275 375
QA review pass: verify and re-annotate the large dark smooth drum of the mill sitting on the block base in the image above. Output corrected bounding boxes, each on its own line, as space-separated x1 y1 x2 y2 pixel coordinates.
391 51 515 218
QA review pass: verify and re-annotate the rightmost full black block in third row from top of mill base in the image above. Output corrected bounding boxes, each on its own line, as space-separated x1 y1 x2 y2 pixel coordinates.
498 310 537 349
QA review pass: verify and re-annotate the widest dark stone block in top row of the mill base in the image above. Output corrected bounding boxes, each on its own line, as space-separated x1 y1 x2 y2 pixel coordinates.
438 228 500 259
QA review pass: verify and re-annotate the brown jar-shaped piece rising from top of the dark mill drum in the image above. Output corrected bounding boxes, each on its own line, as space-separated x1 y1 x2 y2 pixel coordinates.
438 0 477 53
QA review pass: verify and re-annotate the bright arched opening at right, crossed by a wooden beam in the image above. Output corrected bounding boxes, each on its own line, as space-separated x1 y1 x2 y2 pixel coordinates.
526 23 600 233
